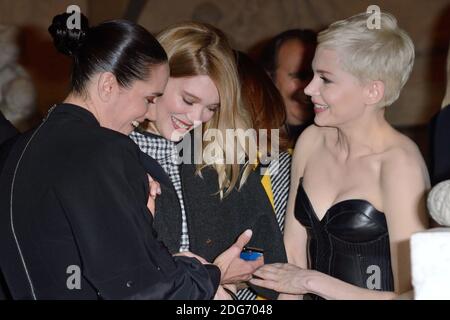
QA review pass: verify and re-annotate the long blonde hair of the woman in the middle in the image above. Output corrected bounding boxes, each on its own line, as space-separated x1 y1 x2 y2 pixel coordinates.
157 22 252 197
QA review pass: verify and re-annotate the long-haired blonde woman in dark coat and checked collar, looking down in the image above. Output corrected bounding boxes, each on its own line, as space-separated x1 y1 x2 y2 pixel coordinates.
131 22 286 298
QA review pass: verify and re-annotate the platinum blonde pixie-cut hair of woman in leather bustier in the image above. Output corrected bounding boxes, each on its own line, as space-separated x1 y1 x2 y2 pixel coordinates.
318 12 415 107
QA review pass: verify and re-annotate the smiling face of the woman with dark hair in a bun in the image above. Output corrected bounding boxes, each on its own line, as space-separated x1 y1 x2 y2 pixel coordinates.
106 63 169 135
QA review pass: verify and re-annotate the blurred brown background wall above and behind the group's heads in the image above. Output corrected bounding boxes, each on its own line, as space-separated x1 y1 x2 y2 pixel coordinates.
0 0 450 129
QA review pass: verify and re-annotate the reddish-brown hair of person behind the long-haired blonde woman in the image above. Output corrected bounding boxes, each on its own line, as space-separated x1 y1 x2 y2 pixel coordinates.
235 51 292 151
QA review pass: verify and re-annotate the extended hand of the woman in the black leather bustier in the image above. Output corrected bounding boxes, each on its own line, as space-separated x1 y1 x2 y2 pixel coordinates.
250 263 314 295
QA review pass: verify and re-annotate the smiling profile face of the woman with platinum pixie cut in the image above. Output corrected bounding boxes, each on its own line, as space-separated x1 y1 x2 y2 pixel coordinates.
305 47 366 127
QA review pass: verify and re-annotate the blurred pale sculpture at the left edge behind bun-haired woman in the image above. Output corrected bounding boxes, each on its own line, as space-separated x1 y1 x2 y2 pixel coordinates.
0 25 35 129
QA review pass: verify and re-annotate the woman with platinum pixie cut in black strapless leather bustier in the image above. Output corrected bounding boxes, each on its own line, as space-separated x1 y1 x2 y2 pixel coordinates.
251 13 429 299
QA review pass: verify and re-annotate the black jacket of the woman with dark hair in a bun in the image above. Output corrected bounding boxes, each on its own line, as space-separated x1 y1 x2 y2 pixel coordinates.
0 104 220 299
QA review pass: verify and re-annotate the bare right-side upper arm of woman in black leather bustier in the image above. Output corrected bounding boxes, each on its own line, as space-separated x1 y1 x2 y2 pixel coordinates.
381 145 430 293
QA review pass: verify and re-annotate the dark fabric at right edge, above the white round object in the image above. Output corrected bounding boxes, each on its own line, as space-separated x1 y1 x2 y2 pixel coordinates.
429 106 450 185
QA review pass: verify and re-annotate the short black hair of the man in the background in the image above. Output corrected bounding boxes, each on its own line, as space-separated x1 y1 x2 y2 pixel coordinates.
258 29 317 80
